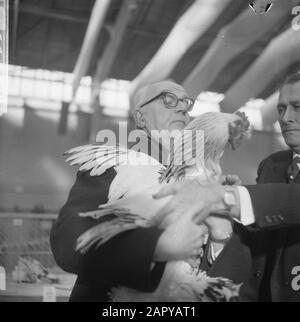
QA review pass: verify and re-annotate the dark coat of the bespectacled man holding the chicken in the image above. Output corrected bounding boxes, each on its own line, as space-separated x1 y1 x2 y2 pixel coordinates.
50 168 165 302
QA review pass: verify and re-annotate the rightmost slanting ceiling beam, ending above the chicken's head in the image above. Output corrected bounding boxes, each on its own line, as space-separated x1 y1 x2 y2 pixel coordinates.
221 28 300 112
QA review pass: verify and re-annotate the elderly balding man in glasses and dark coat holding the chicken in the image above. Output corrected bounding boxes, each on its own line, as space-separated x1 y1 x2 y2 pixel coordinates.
51 81 198 301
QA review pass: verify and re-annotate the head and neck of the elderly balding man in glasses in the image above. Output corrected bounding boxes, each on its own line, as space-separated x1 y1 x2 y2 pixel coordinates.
131 81 194 164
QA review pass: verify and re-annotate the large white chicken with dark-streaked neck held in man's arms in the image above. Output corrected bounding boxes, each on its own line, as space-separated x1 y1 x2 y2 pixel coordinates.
66 112 249 301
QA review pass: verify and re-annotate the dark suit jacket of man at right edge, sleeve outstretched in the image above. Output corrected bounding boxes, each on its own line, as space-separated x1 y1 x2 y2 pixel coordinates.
203 151 300 301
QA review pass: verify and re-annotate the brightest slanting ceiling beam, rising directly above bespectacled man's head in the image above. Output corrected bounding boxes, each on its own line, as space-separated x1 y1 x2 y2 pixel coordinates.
131 0 231 94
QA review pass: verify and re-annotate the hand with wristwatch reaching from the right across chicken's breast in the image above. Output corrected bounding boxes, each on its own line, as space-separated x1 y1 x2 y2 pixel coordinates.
153 180 225 227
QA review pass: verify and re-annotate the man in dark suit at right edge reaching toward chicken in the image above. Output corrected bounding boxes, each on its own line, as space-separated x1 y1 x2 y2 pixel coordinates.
157 73 300 301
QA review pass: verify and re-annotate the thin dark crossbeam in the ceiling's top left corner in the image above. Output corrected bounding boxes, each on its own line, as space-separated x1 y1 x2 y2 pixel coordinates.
15 3 89 24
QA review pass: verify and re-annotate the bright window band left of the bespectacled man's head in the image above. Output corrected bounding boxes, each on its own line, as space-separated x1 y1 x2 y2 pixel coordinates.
8 65 130 117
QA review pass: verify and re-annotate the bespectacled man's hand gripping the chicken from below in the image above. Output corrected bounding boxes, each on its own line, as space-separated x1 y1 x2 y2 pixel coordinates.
154 214 208 262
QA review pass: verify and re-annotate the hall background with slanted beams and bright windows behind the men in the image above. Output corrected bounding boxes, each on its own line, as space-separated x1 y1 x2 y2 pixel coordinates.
0 0 300 302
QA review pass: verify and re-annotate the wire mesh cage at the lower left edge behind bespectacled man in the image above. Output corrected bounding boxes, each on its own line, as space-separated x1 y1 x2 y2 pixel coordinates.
0 213 57 274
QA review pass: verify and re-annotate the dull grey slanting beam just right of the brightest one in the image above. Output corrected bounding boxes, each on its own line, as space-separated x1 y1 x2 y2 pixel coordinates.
183 0 300 97
